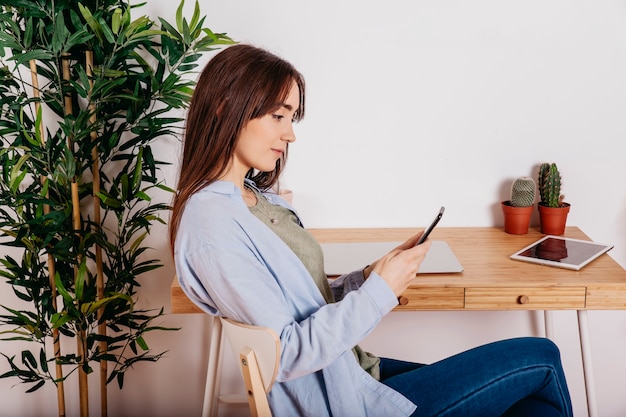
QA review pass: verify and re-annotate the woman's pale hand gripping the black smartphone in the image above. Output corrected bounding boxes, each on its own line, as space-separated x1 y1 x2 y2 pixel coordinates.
363 233 431 297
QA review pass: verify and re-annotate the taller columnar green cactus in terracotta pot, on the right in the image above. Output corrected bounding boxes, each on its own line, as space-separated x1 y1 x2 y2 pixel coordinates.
537 162 570 235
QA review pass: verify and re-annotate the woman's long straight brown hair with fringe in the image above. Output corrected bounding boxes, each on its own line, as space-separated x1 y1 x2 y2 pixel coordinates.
170 44 304 251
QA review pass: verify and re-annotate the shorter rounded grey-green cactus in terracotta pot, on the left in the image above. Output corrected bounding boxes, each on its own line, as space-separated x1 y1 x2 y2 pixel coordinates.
501 177 536 235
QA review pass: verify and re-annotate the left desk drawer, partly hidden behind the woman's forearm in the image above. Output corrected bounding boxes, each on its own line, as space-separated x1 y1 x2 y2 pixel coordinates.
396 287 465 310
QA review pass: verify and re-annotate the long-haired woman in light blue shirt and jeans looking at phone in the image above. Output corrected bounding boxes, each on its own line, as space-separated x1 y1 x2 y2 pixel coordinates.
170 45 572 417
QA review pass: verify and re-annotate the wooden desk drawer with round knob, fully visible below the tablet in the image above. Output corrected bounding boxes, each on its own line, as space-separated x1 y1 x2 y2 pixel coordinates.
465 287 586 310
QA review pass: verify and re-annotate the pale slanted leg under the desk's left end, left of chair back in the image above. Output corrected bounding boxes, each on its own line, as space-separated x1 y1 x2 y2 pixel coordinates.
202 315 222 417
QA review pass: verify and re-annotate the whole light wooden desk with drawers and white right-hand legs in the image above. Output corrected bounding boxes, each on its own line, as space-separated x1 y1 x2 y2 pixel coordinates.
171 227 626 417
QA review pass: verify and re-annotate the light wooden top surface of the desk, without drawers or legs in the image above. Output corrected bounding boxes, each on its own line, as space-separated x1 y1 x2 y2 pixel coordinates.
309 227 626 288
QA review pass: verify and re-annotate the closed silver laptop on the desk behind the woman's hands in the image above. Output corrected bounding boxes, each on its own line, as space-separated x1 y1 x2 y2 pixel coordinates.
321 240 463 276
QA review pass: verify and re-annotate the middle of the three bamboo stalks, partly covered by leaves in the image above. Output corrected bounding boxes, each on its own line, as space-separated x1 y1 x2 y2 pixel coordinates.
61 54 89 417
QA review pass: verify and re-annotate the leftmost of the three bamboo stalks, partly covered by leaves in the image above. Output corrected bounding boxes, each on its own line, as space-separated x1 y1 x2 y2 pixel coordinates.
30 59 65 417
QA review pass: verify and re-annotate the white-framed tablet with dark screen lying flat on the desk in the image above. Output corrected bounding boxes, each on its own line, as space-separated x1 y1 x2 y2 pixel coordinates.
511 235 613 271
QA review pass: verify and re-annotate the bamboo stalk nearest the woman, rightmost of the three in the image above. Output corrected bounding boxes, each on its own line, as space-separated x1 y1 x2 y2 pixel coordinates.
85 51 108 417
